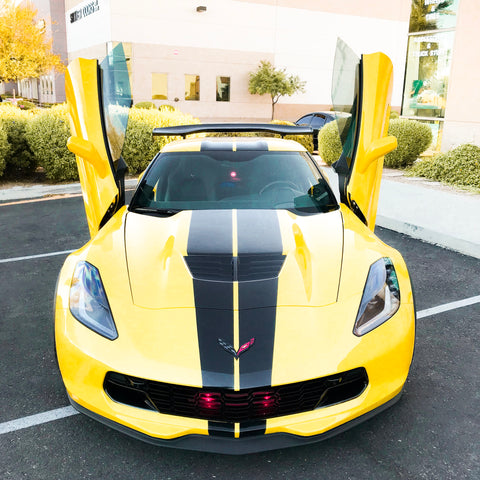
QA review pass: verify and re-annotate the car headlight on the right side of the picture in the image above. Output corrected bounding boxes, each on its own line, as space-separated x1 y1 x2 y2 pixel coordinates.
353 257 400 337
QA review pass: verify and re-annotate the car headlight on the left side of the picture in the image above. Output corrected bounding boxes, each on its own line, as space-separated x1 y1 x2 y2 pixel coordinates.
70 262 118 340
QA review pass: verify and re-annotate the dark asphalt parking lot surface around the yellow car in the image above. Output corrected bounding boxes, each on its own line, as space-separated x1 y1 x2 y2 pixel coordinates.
0 197 480 480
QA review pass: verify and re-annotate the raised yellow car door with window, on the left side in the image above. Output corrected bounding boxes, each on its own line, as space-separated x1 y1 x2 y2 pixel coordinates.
65 44 132 237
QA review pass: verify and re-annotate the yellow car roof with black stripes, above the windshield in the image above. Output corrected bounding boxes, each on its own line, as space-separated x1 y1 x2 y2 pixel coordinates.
161 136 307 153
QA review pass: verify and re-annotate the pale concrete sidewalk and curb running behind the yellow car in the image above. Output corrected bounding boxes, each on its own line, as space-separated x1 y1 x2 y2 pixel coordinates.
0 167 480 258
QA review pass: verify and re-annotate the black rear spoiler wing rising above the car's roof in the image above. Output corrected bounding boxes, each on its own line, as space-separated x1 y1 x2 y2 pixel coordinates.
153 123 313 138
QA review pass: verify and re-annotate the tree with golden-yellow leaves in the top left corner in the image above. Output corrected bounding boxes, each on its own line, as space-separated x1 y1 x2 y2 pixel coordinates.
0 0 64 82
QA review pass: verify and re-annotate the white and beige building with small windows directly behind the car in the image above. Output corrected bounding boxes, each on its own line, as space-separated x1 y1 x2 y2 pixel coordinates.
65 0 410 120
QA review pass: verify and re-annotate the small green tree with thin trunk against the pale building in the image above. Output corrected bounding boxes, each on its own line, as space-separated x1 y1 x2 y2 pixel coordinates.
248 60 306 120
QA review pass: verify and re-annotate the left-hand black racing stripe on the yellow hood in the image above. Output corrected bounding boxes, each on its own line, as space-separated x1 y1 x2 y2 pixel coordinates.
187 210 234 389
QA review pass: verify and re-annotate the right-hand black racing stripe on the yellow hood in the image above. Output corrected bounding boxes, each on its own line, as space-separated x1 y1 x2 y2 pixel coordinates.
237 210 283 389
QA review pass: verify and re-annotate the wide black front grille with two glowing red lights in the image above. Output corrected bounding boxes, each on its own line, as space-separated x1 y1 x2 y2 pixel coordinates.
104 368 368 422
